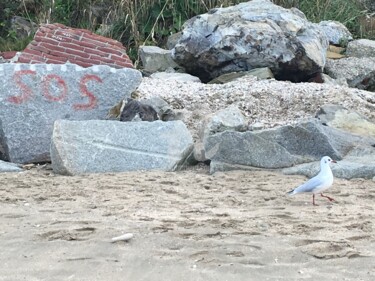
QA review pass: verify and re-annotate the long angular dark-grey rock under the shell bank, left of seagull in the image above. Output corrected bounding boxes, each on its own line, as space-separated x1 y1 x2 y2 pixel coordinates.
204 119 370 173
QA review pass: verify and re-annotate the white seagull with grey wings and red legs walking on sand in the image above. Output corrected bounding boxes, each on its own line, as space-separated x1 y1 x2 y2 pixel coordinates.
288 156 337 206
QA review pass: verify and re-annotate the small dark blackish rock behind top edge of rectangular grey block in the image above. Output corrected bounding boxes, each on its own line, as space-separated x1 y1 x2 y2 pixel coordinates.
120 99 159 121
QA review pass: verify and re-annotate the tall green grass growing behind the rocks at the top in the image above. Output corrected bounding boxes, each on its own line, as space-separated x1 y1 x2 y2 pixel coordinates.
0 0 375 60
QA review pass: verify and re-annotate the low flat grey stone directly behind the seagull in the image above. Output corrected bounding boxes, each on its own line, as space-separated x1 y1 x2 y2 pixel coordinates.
283 154 375 179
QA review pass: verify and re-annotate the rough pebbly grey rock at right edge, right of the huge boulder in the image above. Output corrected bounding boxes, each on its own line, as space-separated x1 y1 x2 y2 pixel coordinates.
324 57 375 91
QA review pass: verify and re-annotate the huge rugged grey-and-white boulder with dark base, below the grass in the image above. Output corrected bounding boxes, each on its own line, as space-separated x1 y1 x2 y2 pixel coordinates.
172 0 328 82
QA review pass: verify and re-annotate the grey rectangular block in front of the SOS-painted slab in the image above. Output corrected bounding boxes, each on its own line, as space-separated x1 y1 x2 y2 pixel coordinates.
51 120 193 175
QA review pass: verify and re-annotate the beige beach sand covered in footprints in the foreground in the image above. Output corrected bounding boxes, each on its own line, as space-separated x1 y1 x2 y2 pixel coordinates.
0 166 375 281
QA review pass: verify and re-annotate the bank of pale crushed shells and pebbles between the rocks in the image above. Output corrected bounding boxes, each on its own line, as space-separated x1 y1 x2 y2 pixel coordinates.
138 76 375 140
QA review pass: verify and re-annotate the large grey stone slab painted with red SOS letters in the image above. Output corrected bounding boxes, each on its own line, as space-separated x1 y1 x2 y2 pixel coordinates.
0 64 142 163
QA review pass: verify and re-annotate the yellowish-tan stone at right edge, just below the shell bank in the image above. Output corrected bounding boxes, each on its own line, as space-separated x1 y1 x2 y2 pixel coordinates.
315 104 375 138
